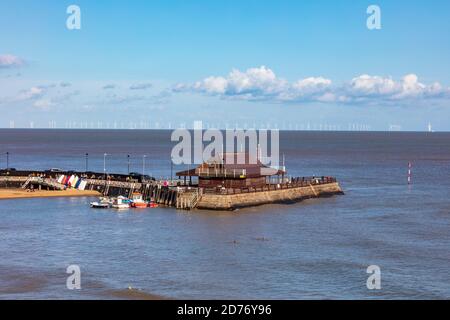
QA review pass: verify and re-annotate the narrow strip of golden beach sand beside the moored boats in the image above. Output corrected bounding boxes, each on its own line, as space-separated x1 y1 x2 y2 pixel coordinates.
0 189 100 200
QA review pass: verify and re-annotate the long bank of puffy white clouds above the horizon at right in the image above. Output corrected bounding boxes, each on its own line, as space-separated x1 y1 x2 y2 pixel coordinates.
177 66 450 104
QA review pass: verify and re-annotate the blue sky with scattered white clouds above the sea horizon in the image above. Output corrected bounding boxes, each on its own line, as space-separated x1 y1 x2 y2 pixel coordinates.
0 0 450 131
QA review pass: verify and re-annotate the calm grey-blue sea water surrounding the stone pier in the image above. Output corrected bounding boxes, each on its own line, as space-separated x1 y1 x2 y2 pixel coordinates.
0 130 450 299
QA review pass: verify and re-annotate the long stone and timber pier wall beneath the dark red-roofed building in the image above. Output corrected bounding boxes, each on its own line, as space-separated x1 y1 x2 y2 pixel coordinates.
0 171 343 210
